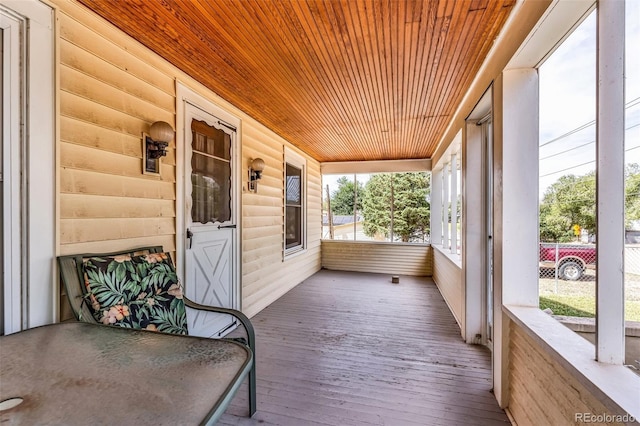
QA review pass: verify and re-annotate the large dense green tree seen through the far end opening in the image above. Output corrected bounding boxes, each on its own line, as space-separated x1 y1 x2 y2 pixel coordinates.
362 172 431 242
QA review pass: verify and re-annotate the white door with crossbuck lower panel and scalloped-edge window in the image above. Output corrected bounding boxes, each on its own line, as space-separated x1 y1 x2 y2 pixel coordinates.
184 102 239 336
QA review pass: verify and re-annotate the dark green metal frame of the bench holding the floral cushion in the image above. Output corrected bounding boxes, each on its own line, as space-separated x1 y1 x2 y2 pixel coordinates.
58 246 256 418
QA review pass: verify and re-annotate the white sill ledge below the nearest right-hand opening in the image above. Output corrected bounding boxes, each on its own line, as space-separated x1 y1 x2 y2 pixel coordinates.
503 305 640 419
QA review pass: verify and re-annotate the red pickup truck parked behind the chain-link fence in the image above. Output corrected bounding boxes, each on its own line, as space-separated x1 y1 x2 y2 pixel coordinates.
540 243 596 281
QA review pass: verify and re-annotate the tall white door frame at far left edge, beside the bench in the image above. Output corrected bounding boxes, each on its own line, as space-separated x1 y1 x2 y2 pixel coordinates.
0 0 58 334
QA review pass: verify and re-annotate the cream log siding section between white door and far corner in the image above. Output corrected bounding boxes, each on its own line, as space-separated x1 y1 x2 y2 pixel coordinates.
242 122 322 316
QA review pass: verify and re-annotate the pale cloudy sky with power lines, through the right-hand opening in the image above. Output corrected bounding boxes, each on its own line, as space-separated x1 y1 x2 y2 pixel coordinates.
539 1 640 196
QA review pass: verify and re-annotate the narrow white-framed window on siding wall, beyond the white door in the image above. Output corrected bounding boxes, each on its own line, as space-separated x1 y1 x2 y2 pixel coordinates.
284 149 307 256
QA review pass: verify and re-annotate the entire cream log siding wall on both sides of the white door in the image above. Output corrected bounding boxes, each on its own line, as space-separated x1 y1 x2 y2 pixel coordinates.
52 0 321 319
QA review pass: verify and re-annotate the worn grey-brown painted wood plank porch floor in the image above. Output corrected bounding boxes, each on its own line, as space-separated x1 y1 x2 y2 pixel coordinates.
219 270 509 426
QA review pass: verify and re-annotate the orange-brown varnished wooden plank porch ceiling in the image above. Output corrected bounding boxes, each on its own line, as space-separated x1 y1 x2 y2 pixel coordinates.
80 0 515 161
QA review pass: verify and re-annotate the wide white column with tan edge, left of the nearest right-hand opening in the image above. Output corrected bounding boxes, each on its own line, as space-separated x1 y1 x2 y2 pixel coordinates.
490 68 539 408
